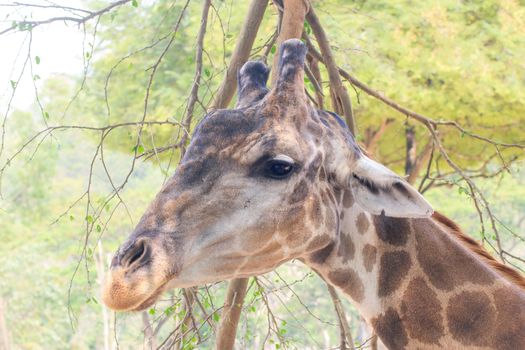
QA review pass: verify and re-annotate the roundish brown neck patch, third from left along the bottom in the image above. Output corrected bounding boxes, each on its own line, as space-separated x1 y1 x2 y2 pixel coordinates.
447 292 496 346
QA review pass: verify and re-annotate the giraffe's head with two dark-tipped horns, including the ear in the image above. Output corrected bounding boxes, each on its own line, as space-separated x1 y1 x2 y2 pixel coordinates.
104 40 432 310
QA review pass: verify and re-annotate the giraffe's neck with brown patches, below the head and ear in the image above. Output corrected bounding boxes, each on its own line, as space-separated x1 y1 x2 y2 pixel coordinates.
305 191 525 349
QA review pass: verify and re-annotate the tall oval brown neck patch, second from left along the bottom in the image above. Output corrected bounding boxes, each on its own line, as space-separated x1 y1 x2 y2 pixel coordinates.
401 277 445 345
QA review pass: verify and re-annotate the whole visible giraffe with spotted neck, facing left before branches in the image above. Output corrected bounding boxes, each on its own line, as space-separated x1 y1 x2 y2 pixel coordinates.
103 39 525 350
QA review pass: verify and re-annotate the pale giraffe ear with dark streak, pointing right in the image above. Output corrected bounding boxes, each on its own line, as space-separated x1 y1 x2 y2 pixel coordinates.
350 155 434 218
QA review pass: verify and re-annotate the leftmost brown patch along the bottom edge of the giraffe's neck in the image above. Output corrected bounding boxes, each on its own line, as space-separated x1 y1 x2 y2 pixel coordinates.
372 308 408 350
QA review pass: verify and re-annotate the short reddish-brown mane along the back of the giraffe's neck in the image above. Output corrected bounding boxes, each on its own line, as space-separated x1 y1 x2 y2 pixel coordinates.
432 211 525 290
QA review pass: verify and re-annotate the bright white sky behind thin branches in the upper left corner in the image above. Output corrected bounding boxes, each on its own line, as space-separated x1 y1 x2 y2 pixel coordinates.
0 1 85 115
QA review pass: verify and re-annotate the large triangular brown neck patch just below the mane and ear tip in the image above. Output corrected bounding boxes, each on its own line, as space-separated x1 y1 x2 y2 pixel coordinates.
413 219 495 290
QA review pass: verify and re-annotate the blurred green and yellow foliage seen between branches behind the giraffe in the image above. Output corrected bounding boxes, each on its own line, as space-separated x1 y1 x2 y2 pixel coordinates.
0 0 525 349
